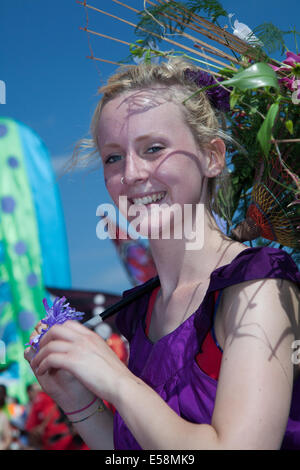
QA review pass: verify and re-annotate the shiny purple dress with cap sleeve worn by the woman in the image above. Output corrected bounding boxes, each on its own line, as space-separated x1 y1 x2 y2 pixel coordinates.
114 247 300 450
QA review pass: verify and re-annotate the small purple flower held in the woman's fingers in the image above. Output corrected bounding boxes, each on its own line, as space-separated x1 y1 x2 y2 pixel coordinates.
27 297 84 351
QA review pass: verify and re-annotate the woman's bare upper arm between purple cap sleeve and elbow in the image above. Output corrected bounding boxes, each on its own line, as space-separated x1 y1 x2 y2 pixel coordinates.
212 279 300 449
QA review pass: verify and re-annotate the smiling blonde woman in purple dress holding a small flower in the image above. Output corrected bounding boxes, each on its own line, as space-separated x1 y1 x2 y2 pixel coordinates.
26 60 300 449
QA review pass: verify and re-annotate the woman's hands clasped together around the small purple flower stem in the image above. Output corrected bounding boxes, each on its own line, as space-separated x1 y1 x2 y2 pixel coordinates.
25 320 131 412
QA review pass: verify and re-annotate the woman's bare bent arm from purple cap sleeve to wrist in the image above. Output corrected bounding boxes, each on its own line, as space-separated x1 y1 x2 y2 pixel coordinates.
111 279 299 449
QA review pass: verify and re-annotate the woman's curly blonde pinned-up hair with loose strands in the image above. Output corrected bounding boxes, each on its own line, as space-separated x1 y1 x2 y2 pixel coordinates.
72 58 239 225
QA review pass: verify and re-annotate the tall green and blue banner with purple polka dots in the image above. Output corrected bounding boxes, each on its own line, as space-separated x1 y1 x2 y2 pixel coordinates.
0 117 71 403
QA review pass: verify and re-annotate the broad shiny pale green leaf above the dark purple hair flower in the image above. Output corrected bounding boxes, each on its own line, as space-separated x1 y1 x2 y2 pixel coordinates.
222 62 279 91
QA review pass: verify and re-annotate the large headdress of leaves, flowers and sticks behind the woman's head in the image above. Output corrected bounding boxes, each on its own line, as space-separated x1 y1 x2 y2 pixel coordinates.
78 0 300 260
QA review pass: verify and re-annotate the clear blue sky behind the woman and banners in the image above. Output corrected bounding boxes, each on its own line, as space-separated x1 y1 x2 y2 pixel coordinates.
0 0 300 294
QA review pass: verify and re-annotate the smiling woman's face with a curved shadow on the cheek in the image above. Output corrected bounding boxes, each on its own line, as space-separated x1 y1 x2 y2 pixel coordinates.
98 89 212 237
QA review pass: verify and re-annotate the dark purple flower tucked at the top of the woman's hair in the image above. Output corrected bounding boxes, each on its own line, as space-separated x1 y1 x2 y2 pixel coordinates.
184 68 230 112
